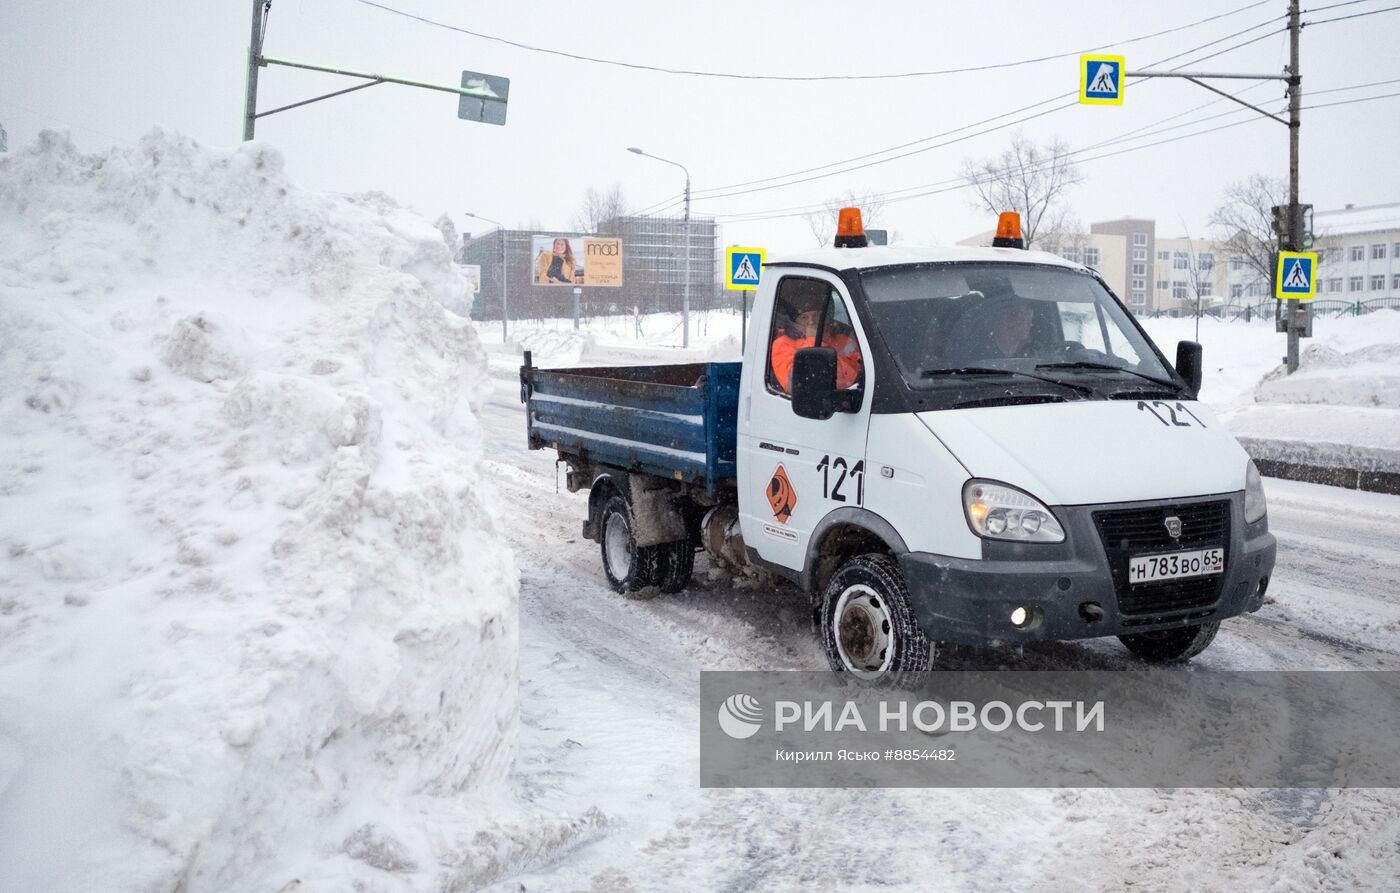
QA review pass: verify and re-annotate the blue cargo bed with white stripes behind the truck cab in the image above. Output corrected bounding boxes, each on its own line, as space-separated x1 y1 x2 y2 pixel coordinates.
521 353 742 493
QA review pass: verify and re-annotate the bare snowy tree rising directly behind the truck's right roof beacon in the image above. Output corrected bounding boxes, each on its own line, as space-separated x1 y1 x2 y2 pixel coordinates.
959 133 1084 248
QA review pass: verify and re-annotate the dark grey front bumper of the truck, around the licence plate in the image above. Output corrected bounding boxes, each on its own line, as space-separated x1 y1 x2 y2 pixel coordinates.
899 493 1277 644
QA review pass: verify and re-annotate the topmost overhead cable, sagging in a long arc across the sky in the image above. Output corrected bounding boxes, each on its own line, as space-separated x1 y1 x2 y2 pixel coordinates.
344 0 1271 81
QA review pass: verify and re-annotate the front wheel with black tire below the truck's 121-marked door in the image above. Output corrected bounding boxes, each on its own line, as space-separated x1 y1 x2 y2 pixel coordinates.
820 554 930 684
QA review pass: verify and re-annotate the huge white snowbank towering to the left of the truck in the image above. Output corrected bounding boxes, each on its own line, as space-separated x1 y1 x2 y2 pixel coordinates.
0 130 517 892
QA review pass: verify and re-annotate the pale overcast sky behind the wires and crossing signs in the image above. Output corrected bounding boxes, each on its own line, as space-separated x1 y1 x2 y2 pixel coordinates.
0 0 1400 252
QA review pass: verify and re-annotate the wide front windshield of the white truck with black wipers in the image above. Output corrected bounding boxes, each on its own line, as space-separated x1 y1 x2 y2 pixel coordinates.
861 262 1177 392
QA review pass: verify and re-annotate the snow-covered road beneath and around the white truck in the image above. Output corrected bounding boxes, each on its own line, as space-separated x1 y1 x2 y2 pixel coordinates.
483 354 1400 892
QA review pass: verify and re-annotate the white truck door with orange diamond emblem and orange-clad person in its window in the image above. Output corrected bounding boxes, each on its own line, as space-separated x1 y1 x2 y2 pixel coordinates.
738 270 871 570
